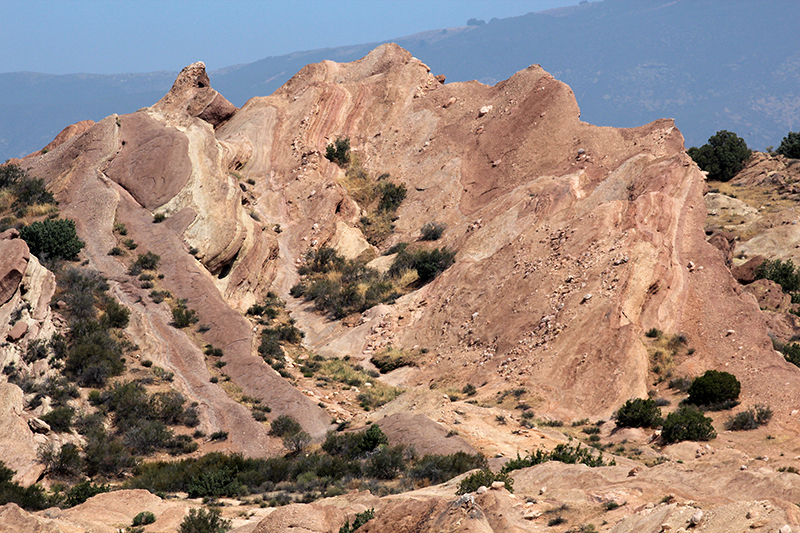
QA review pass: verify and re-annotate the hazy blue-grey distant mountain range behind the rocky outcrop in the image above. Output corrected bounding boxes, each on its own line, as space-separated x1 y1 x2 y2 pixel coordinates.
0 0 800 159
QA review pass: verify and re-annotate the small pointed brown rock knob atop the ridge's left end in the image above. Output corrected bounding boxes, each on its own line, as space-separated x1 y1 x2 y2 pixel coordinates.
152 61 237 128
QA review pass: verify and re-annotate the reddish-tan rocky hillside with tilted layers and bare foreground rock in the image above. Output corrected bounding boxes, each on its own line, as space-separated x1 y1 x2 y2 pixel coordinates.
0 44 800 532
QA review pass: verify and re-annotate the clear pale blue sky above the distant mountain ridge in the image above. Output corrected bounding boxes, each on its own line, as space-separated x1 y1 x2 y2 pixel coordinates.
0 0 578 74
